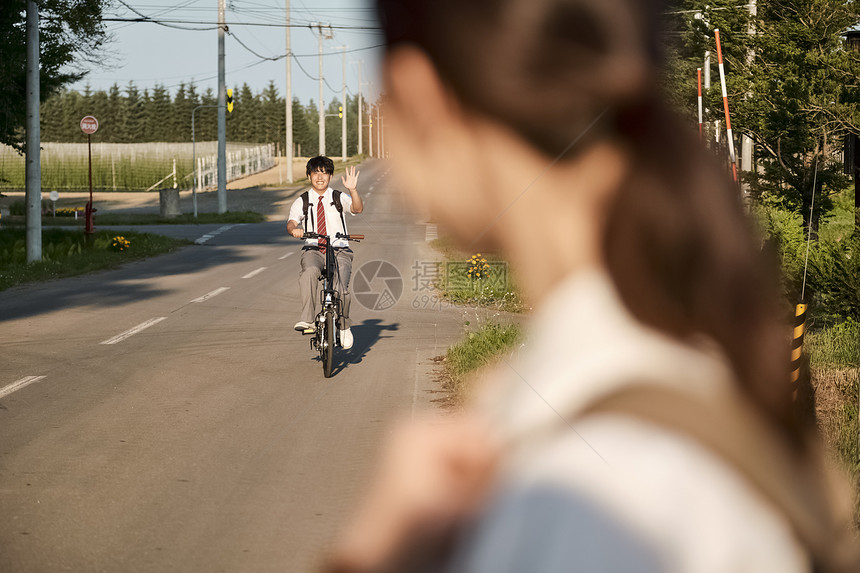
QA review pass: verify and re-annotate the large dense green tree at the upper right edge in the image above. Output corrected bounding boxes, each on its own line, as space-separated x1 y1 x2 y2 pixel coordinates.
737 0 860 235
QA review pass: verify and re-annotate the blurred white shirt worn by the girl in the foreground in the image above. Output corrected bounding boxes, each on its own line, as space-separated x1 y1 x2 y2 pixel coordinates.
457 269 810 573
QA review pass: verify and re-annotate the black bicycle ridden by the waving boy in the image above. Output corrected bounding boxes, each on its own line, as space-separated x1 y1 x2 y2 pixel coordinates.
302 231 364 378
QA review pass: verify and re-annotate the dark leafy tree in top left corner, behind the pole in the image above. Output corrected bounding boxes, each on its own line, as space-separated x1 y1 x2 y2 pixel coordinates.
0 0 107 151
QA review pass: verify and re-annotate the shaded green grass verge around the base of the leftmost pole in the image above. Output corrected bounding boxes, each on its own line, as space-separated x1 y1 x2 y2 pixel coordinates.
0 229 190 291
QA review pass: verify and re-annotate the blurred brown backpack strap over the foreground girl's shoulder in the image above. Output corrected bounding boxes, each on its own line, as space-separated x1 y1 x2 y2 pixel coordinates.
578 384 860 573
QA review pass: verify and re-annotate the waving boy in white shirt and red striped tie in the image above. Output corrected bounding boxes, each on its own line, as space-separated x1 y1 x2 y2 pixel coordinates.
287 155 364 349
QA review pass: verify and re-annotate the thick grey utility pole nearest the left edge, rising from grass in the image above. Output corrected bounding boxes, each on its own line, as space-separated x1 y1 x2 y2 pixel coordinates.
25 0 42 263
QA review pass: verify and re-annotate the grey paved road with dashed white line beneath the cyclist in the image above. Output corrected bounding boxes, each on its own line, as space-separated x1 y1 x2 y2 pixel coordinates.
0 163 461 572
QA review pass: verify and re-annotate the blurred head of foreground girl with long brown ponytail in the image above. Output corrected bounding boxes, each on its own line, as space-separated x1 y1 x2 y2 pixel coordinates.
378 0 804 442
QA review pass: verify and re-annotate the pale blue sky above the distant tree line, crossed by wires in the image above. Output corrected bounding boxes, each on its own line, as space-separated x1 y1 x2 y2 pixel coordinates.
70 0 383 104
